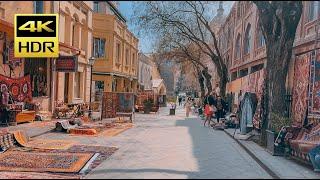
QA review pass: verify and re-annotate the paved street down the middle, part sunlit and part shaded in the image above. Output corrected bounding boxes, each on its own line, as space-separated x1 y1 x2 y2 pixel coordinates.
82 107 271 178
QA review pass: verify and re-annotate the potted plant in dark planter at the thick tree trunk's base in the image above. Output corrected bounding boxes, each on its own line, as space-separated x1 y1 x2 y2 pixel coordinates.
266 113 292 156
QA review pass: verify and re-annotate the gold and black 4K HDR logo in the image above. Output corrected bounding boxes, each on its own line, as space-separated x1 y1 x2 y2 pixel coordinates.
14 14 59 58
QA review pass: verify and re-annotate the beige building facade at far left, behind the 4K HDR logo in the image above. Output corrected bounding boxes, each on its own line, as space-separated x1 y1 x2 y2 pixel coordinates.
0 1 93 112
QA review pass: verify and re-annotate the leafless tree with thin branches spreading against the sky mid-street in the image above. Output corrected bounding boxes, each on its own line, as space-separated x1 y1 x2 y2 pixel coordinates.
134 1 228 96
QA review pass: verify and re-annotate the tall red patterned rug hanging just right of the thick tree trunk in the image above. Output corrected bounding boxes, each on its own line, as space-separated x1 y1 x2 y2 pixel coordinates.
292 54 310 123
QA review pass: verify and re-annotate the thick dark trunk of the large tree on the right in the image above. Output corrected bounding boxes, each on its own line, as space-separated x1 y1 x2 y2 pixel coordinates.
253 1 303 145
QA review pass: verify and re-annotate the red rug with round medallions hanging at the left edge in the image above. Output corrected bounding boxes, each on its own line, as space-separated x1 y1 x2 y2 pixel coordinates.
0 75 32 102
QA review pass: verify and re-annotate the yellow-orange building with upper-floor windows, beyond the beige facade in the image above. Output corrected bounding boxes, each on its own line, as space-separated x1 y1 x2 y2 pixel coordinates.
92 1 139 92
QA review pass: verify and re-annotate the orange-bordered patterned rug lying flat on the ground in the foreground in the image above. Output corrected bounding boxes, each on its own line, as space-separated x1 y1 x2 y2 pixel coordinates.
0 151 93 173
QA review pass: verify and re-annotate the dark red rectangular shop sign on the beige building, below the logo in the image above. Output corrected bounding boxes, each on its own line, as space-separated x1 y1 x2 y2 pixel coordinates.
56 56 78 72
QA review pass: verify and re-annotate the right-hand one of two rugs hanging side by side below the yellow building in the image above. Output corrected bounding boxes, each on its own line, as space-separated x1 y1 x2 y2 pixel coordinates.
117 93 134 113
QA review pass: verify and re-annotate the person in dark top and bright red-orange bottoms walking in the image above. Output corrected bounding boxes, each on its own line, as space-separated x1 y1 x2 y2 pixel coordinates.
203 91 216 126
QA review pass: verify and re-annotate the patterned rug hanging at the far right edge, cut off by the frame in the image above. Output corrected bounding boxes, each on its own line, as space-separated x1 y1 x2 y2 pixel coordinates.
308 52 320 118
